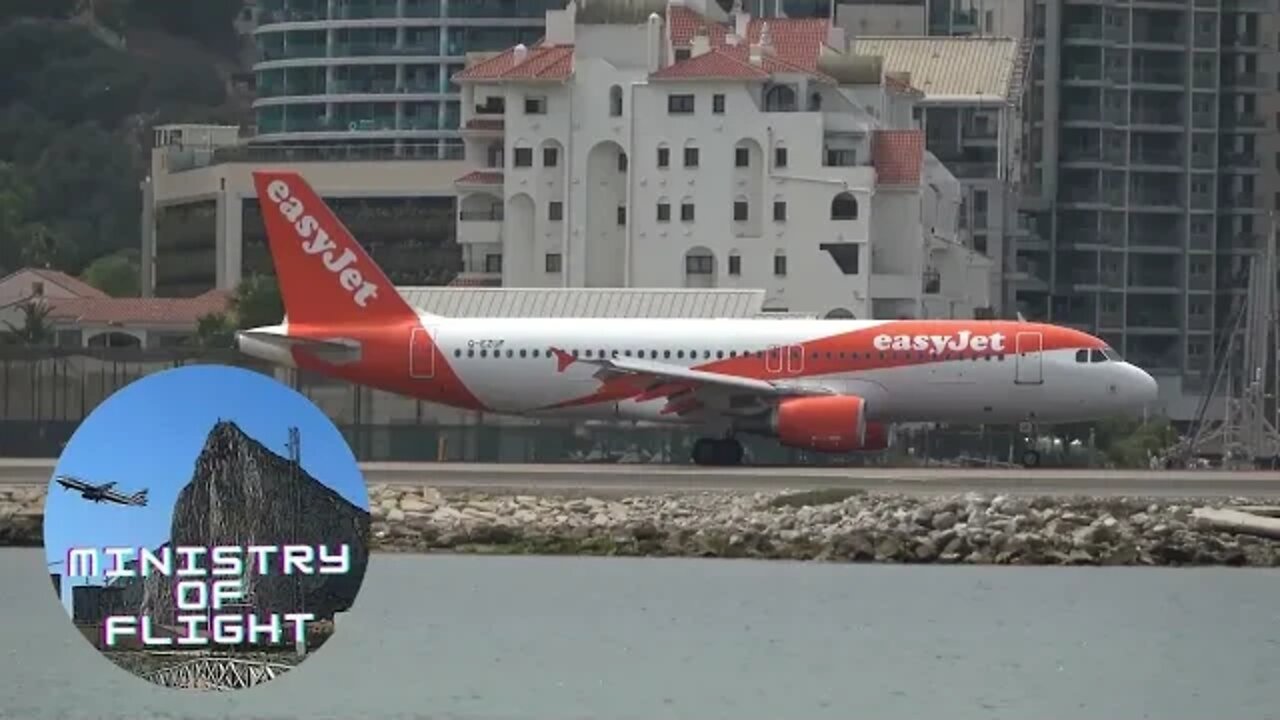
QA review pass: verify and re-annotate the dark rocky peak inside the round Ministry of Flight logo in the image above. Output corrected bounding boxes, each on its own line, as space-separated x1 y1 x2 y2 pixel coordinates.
141 421 370 625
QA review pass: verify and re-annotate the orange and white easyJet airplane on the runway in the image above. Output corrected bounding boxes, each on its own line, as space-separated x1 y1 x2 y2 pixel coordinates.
237 172 1156 465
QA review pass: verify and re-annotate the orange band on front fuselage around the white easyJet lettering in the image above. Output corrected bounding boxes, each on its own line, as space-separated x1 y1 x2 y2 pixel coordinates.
529 320 1106 409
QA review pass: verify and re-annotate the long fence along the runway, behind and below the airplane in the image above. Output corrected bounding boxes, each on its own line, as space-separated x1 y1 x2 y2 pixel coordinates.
0 347 1049 466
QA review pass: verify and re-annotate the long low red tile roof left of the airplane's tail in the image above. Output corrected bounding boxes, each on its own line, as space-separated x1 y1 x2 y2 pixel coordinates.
49 290 230 327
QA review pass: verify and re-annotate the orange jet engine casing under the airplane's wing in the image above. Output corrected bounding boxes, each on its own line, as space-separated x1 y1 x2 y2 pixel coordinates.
773 395 888 452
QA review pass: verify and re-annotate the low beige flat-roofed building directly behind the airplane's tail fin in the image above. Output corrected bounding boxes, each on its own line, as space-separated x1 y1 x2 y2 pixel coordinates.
142 126 463 297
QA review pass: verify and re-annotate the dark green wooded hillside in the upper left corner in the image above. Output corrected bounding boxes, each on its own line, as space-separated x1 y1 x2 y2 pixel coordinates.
0 0 248 295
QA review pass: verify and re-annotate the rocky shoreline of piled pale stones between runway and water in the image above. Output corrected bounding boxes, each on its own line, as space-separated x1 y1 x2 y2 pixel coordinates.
0 486 1280 566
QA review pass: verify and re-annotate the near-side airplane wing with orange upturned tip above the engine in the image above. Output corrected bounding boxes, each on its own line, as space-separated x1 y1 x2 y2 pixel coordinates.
554 350 836 415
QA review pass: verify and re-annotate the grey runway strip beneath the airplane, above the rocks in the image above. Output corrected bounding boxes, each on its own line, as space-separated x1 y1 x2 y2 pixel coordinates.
0 459 1280 497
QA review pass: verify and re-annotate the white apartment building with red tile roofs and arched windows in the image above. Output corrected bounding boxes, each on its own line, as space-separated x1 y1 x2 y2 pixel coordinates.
454 0 991 318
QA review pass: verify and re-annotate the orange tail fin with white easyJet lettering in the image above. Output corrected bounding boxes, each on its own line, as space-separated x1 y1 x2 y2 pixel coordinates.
253 170 417 325
